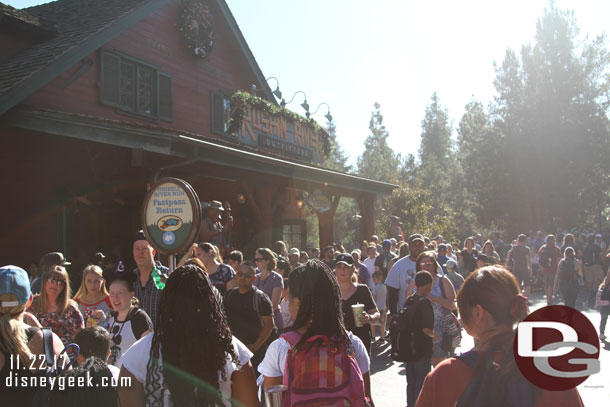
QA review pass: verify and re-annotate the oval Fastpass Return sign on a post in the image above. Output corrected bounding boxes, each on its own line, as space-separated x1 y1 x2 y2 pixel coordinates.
142 178 201 255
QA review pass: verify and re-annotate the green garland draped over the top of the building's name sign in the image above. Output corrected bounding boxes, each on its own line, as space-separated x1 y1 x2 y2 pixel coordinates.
227 91 330 158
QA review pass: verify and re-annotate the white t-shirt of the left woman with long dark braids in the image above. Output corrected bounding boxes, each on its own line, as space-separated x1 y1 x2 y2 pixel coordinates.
123 334 253 407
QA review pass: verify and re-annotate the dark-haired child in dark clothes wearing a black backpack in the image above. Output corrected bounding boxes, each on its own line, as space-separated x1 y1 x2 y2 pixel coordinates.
405 270 438 407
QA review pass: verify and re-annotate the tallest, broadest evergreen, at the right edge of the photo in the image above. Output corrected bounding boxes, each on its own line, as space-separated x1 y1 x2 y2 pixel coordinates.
494 2 610 228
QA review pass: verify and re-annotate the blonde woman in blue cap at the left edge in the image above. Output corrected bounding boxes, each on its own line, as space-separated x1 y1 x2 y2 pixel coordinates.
0 266 63 406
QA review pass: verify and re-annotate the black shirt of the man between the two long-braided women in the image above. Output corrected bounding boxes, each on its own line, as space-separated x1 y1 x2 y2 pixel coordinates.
224 286 273 344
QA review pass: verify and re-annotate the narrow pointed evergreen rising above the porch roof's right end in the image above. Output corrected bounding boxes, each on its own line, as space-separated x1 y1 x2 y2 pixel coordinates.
358 103 401 183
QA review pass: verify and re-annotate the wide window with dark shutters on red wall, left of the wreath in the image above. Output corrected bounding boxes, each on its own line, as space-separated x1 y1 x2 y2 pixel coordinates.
100 50 174 121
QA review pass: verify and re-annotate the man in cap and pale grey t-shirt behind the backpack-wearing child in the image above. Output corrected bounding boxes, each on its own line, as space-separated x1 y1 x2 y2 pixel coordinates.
385 234 425 314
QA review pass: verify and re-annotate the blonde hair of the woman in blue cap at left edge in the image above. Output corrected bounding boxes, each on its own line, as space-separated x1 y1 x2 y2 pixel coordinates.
0 293 32 366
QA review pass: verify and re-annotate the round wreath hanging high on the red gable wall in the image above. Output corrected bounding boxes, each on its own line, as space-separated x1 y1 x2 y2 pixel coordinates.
179 0 215 60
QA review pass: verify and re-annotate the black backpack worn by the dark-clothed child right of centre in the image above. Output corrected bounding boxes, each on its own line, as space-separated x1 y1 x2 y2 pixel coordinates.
390 295 421 362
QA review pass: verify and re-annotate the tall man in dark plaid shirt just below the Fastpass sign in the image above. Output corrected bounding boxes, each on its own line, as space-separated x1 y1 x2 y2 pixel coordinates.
133 230 169 327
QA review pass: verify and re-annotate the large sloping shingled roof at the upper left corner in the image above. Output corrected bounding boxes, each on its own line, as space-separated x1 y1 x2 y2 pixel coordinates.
0 0 168 115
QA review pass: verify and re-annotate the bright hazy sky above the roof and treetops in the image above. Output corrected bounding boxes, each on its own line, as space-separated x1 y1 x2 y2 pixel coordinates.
2 0 610 164
